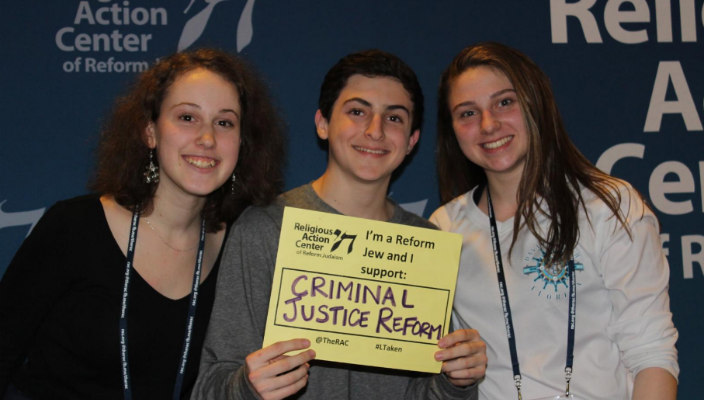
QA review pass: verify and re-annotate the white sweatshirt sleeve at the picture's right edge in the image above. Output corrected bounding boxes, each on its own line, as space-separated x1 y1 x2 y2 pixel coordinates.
596 184 679 378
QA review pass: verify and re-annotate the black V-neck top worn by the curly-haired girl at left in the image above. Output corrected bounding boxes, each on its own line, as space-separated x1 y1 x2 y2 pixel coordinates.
0 196 220 399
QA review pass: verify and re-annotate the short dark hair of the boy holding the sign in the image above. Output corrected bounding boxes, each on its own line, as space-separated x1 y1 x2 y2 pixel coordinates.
318 49 423 132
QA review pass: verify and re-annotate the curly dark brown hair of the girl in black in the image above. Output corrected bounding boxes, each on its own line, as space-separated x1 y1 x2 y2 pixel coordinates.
89 49 284 231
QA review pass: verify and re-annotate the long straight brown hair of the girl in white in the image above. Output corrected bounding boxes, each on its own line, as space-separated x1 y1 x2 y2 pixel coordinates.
436 42 630 266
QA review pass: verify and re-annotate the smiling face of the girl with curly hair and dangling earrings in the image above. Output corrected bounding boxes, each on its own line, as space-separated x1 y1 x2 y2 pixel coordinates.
146 68 242 203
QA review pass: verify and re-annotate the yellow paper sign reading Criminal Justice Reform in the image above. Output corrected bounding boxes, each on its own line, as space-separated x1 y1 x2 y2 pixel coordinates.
264 207 462 373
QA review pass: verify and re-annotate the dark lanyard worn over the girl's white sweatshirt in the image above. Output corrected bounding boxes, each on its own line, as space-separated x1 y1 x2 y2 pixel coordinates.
486 190 577 400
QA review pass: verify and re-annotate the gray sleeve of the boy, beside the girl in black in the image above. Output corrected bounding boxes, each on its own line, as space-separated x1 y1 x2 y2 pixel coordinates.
191 207 280 400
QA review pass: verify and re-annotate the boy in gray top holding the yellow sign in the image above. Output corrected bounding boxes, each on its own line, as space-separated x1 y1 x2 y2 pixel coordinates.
192 50 486 400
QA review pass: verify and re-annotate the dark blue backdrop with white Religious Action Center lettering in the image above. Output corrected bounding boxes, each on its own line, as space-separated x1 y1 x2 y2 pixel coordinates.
0 0 704 398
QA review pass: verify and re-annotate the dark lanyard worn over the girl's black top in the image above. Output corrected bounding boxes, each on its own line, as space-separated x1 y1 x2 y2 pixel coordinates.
120 211 205 400
